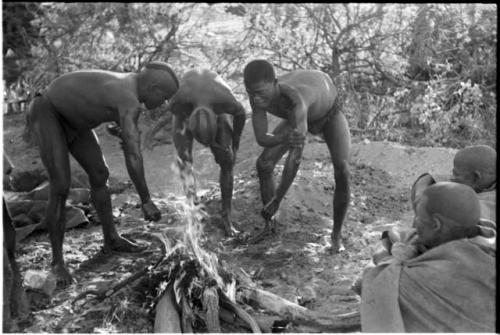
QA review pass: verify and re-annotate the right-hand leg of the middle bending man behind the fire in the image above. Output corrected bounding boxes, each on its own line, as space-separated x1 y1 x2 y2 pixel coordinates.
210 114 237 236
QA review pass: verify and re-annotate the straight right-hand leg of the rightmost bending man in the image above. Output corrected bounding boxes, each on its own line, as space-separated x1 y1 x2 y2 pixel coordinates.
323 112 351 253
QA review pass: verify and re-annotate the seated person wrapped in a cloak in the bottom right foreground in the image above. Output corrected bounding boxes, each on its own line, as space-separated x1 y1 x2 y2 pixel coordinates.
361 182 496 332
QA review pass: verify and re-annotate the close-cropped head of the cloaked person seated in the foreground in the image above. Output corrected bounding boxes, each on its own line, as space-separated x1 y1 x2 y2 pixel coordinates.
414 182 480 248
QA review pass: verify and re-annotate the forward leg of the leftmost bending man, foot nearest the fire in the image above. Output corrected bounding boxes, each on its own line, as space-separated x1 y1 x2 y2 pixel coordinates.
69 130 143 252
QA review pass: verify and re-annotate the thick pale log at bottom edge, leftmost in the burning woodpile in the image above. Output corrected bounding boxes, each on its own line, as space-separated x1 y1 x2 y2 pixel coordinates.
154 285 182 333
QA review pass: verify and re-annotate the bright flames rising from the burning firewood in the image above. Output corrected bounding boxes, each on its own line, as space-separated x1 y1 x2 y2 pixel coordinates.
172 157 225 288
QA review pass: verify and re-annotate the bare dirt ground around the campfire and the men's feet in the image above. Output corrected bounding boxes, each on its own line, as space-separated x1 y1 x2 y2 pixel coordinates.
3 111 455 333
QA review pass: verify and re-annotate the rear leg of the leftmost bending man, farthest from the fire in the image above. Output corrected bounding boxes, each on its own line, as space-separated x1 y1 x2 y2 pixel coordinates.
29 96 73 286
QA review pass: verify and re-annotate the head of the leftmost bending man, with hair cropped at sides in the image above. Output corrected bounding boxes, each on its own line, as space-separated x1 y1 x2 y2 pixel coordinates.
139 61 179 109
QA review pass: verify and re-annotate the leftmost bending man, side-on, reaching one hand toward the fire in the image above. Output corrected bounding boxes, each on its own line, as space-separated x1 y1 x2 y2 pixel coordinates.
29 65 177 286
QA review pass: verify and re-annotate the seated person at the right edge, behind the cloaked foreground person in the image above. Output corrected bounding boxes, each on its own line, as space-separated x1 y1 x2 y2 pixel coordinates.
451 145 497 222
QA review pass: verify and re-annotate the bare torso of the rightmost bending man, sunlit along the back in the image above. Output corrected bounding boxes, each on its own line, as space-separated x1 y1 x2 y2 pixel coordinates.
268 70 337 122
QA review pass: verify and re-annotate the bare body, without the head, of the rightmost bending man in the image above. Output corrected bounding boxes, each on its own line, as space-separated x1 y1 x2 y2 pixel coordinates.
246 70 350 253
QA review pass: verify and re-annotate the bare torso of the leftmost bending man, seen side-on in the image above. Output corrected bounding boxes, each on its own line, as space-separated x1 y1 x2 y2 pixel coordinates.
42 70 140 129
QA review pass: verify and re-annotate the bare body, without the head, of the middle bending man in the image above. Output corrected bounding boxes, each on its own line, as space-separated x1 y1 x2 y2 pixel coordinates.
146 69 246 236
